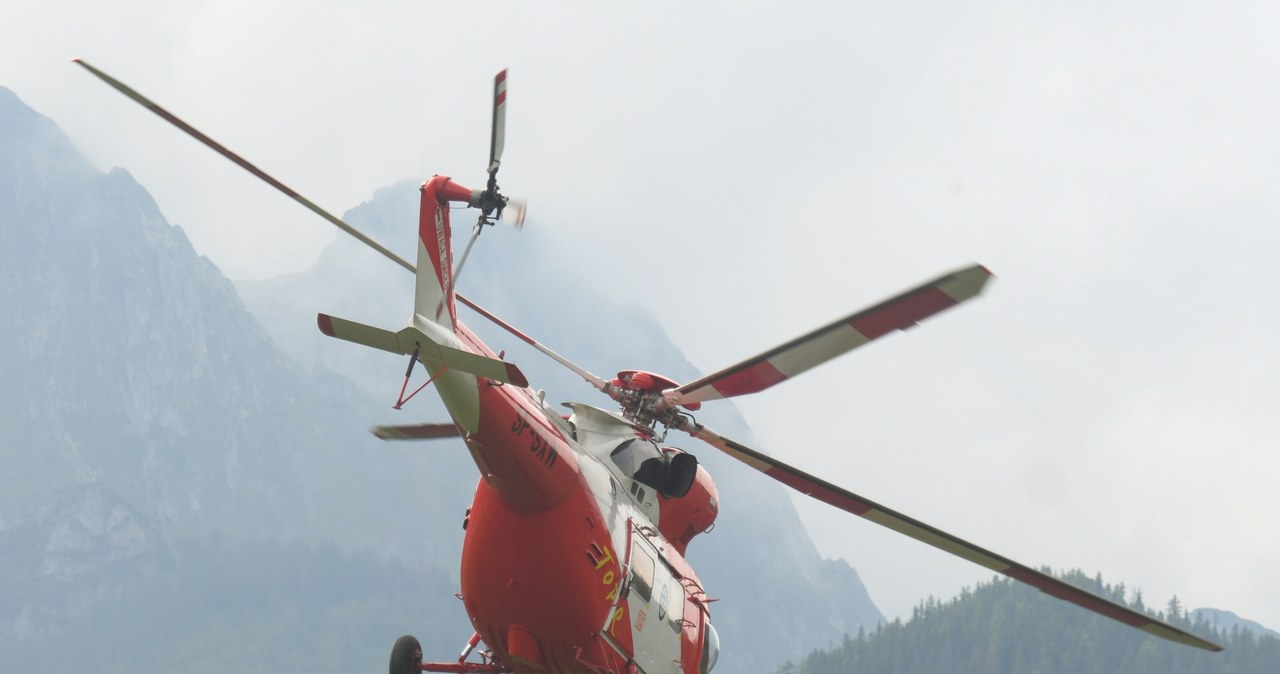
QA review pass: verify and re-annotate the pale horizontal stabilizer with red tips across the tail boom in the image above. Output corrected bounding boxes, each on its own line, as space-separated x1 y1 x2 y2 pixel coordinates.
316 313 529 388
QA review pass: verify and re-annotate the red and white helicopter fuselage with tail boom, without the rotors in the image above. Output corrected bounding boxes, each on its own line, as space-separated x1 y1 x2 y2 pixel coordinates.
411 178 718 673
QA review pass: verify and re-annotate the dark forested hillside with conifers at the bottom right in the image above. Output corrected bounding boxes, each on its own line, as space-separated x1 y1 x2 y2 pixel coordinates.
781 572 1280 674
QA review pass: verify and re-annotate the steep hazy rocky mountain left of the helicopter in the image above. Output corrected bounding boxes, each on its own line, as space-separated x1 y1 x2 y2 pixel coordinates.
0 88 470 671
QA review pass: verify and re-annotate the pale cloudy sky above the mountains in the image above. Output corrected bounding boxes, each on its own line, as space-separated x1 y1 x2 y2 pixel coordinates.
10 0 1280 639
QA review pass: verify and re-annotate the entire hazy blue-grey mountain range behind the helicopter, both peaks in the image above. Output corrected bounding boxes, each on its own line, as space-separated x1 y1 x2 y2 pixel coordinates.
0 88 879 671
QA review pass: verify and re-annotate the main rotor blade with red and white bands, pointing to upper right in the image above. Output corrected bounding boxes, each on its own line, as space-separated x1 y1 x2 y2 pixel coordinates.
664 265 991 405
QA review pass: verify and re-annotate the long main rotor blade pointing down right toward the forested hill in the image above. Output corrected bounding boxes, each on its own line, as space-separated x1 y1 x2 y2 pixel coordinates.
675 417 1222 651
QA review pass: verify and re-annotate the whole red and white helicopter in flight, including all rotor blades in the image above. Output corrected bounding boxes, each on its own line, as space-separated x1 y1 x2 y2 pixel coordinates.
74 59 1221 674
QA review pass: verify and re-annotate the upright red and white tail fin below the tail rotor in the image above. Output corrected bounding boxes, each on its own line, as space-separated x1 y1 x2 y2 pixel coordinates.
413 175 475 333
